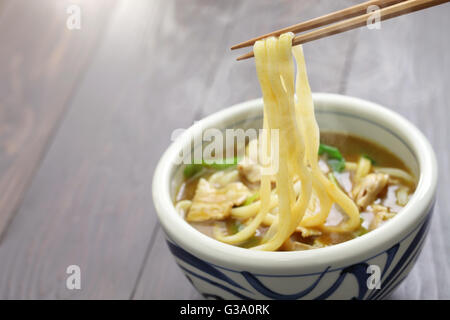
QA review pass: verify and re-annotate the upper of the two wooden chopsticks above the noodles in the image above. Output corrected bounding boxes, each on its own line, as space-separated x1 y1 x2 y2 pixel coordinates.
231 0 407 50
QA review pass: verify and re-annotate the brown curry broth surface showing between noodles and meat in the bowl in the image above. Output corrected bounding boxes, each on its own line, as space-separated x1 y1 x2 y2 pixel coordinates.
175 132 415 251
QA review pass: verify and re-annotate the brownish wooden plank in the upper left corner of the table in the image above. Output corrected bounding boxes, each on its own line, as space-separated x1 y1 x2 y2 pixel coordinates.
0 0 114 239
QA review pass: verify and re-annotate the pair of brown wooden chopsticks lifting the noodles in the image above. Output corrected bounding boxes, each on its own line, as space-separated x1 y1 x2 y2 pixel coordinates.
233 0 450 61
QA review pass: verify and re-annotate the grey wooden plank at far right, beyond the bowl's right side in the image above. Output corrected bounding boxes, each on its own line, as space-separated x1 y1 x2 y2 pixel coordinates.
345 5 450 299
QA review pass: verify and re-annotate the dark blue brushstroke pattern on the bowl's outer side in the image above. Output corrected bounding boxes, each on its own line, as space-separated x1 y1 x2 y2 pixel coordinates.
167 207 433 300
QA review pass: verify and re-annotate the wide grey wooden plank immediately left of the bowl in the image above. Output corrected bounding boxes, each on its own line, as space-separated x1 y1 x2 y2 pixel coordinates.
0 0 243 299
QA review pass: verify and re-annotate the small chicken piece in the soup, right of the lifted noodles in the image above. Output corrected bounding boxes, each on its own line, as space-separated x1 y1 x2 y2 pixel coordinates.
352 173 389 210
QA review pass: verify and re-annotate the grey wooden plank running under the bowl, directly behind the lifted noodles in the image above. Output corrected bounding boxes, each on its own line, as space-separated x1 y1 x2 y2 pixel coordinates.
133 0 362 299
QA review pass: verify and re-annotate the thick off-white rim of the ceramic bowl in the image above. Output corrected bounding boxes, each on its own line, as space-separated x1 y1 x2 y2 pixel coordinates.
152 93 438 274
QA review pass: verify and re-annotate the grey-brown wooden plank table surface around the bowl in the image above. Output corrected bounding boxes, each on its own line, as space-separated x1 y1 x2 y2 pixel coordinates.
0 0 450 299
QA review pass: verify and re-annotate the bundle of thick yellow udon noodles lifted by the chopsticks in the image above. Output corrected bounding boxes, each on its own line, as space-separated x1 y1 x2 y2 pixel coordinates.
214 33 362 251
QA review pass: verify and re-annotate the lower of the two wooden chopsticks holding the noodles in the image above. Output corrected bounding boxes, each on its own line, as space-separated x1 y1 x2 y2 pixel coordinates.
237 0 450 61
